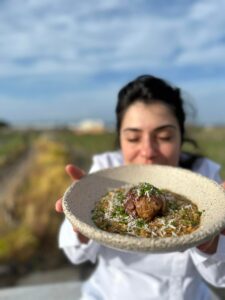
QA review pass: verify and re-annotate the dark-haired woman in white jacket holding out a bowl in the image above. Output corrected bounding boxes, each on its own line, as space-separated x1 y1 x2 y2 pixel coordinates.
56 76 225 300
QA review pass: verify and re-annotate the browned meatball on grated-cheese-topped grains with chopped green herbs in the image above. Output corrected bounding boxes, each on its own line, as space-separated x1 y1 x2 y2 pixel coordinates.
92 182 202 238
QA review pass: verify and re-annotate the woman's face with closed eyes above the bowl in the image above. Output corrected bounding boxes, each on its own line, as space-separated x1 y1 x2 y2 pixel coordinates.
120 101 181 166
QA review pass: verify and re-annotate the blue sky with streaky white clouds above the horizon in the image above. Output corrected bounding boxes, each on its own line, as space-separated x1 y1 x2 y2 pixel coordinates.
0 0 225 125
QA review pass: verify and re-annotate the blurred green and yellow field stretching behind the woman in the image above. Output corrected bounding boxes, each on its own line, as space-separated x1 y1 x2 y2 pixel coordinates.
0 127 225 284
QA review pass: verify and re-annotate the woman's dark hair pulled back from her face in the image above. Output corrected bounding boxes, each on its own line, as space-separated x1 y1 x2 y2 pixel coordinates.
116 75 199 168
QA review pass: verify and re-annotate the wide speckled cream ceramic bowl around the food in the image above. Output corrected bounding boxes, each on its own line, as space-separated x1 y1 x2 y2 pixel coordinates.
63 165 225 253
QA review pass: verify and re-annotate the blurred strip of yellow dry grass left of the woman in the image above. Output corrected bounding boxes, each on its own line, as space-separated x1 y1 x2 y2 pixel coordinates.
0 138 70 261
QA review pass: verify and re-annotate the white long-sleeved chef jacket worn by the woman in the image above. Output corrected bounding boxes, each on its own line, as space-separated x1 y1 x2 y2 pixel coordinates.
59 151 225 300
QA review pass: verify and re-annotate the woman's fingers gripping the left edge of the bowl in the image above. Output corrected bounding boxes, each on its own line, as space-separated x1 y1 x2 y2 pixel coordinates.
55 165 89 244
